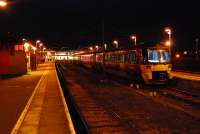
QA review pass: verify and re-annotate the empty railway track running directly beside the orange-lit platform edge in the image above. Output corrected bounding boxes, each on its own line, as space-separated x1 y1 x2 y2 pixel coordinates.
58 63 132 134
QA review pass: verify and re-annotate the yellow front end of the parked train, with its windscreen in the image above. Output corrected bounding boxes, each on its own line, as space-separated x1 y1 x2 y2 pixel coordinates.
140 47 172 84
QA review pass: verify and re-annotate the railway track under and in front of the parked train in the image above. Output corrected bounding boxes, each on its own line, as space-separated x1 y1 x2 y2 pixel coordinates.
90 64 200 114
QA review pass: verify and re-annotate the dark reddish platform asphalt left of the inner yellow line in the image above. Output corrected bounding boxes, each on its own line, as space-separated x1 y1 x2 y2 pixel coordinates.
0 65 46 134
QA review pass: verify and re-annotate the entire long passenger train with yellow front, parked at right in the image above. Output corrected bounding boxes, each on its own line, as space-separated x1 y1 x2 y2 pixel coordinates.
78 43 173 84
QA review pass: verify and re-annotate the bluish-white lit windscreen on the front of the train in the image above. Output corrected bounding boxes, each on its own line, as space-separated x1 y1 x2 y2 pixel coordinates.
148 49 170 63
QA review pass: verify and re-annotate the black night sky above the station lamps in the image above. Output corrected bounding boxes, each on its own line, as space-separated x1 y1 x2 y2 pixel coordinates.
0 0 200 49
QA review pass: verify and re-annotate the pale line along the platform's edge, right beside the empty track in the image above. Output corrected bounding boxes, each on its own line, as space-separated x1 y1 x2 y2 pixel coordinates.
55 68 76 134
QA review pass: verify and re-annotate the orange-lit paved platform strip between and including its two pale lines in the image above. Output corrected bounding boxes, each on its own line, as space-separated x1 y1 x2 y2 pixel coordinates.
11 63 75 134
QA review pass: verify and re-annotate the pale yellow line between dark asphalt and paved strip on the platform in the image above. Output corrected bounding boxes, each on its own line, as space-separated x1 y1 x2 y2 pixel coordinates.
11 71 48 134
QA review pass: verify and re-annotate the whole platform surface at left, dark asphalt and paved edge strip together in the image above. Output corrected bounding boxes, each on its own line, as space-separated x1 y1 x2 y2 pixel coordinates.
0 63 75 134
